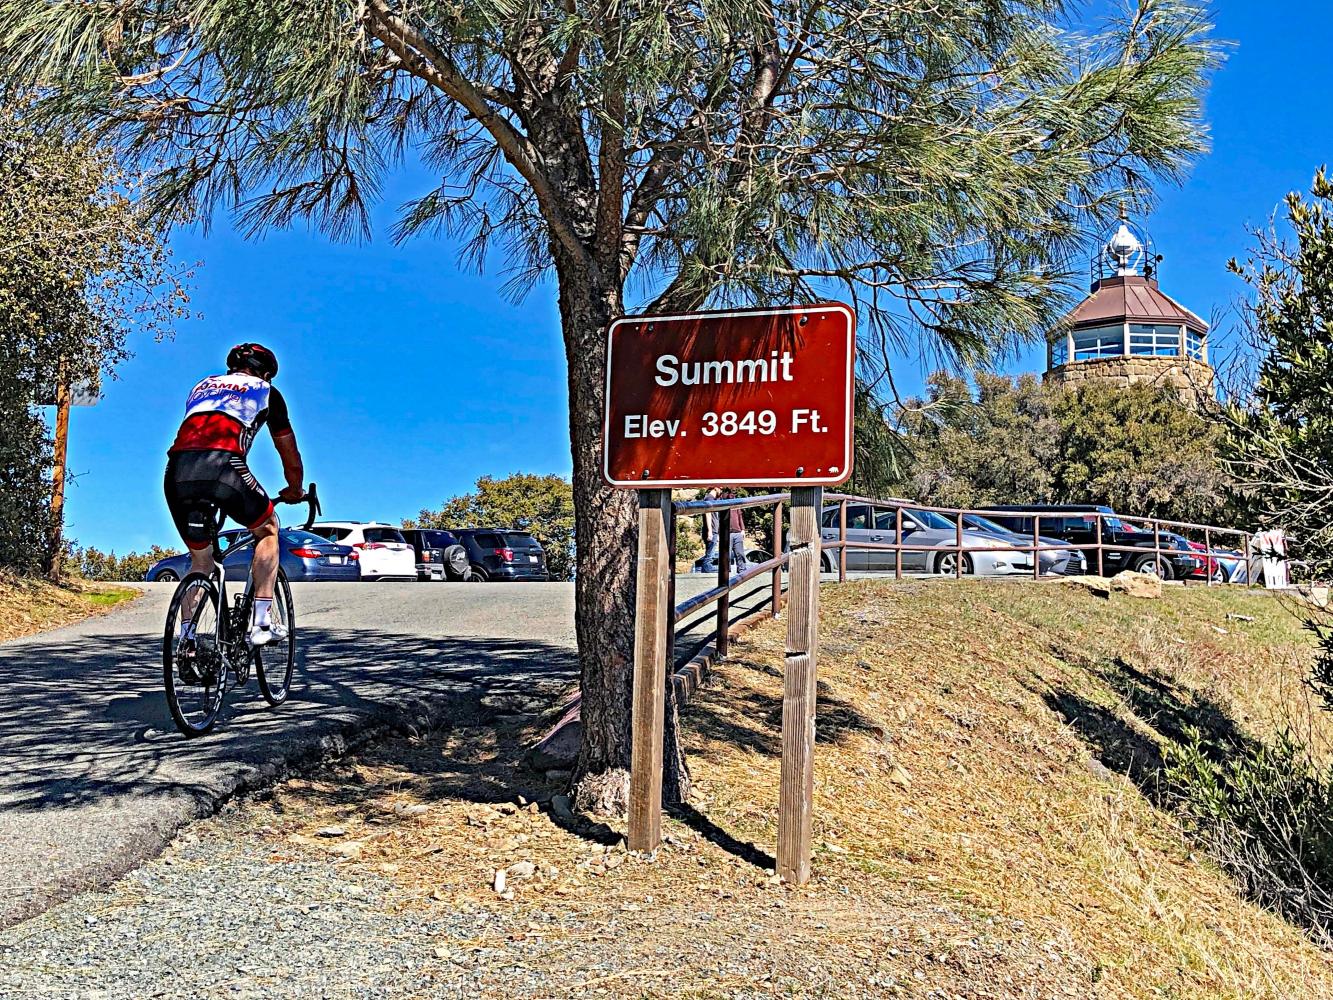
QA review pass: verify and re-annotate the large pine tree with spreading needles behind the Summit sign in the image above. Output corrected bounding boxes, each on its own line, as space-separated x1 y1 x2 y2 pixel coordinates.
0 0 1217 809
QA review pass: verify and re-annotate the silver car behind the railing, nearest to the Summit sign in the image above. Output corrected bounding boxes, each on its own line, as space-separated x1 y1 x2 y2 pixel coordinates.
821 504 1057 576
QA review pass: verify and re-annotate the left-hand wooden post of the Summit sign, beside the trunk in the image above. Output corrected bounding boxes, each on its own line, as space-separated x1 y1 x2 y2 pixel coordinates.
629 489 674 851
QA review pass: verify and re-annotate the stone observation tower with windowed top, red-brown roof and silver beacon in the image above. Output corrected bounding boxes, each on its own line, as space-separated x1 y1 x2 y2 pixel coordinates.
1046 209 1213 401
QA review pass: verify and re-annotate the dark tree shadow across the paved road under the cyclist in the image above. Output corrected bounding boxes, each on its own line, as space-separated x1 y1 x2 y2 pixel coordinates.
0 628 577 817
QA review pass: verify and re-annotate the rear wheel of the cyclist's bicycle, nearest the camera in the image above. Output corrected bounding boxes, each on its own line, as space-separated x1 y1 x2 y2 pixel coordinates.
163 573 227 736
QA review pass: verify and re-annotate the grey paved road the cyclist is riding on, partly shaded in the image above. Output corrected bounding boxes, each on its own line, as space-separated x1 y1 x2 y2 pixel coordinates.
0 576 764 927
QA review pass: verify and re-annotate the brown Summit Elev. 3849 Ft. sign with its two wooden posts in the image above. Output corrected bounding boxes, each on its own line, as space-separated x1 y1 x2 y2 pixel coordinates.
603 303 856 883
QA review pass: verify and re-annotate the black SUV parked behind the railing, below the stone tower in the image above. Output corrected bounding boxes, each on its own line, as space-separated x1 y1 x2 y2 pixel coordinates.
984 504 1202 580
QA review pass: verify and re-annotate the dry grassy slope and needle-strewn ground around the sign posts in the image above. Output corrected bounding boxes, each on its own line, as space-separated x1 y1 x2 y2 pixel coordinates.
204 581 1333 1000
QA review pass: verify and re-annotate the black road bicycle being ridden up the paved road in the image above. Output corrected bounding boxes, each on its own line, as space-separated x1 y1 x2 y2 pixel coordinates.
163 483 320 736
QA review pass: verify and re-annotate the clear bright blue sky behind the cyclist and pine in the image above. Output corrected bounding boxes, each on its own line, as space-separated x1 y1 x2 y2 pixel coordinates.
51 0 1333 552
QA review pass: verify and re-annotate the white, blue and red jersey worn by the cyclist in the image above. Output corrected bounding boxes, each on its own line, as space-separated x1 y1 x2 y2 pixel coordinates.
168 372 292 456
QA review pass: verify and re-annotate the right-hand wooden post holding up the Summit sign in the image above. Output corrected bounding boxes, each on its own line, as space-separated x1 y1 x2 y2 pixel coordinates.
777 487 824 885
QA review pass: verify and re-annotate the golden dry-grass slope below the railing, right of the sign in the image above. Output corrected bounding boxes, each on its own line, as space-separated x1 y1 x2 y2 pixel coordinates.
725 583 1333 997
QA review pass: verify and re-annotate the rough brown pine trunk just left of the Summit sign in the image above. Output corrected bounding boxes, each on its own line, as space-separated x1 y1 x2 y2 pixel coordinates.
556 251 689 815
